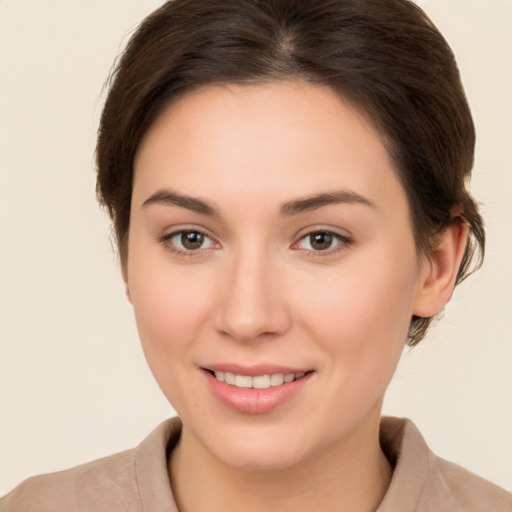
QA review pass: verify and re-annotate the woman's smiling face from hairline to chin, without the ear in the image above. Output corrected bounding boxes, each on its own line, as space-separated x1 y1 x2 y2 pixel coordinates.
127 82 426 468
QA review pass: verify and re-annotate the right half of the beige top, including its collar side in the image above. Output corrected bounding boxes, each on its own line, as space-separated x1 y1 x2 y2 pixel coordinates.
378 418 512 512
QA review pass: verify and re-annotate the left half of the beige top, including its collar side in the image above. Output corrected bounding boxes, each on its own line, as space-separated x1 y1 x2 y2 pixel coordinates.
0 418 181 512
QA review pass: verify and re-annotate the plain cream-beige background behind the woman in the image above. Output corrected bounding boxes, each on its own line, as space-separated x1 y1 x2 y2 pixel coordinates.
0 0 512 494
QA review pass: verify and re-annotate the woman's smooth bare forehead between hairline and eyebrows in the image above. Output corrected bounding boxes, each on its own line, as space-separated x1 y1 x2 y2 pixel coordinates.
134 82 403 216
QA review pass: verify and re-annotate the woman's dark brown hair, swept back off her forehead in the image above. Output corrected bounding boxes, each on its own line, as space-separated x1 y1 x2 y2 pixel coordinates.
96 0 485 345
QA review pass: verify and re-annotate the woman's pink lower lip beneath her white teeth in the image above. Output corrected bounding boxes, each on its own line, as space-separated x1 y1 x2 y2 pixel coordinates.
203 370 312 414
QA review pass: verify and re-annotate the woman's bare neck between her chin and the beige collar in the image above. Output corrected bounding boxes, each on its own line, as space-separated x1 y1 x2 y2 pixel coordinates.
170 412 392 512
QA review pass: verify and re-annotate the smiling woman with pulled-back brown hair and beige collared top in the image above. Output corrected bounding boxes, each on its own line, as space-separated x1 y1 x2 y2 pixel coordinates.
0 0 511 512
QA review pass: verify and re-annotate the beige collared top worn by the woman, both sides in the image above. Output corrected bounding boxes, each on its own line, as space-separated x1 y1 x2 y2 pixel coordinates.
0 418 512 512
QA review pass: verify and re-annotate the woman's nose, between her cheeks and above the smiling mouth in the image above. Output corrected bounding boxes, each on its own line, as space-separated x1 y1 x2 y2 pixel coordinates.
215 249 291 342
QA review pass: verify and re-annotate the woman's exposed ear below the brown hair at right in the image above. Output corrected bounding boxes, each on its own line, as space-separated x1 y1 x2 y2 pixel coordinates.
413 218 468 318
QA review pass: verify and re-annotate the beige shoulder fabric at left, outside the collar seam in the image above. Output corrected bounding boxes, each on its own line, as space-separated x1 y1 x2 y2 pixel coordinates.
0 450 140 512
